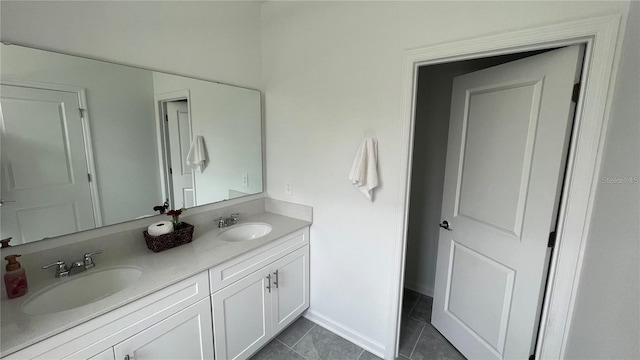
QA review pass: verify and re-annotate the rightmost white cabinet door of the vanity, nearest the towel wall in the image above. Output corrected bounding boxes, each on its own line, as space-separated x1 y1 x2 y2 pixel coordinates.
270 246 309 333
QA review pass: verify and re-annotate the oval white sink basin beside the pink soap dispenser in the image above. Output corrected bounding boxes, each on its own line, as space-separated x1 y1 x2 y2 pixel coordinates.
22 267 142 315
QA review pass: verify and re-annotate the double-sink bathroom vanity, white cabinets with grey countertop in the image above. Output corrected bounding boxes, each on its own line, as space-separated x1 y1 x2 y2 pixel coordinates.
2 212 310 360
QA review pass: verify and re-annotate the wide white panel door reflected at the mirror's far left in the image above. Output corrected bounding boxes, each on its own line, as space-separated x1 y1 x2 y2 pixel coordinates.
0 85 95 244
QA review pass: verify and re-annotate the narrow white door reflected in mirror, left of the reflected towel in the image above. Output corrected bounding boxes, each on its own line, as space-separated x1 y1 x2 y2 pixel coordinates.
164 100 195 209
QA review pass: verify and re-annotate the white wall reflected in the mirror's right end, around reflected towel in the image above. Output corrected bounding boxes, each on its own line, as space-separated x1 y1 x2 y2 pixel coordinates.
153 72 262 206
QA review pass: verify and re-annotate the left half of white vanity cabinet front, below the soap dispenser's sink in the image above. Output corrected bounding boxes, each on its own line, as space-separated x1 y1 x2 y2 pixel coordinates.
3 272 213 360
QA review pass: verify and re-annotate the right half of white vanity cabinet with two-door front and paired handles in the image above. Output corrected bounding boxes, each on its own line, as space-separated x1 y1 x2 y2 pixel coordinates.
210 228 309 360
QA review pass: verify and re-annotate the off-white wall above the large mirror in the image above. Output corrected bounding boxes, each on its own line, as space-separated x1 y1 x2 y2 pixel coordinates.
0 1 260 88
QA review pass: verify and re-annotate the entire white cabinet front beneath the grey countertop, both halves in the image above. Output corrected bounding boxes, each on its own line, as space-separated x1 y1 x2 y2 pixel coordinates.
2 222 309 360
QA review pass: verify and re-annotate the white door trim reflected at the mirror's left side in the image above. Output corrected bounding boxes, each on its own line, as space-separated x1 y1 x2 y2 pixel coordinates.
0 78 102 228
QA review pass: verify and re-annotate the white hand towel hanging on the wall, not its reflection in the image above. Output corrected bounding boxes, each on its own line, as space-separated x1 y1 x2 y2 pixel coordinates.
349 138 378 201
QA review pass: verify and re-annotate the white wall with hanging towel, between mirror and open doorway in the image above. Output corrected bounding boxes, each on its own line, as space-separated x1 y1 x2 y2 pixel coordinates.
262 2 628 353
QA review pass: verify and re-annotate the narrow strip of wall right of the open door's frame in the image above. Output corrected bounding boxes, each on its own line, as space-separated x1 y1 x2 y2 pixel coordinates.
565 2 640 360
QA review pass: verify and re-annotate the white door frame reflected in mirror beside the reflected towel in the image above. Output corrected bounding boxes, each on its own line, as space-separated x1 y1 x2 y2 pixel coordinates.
153 89 198 207
